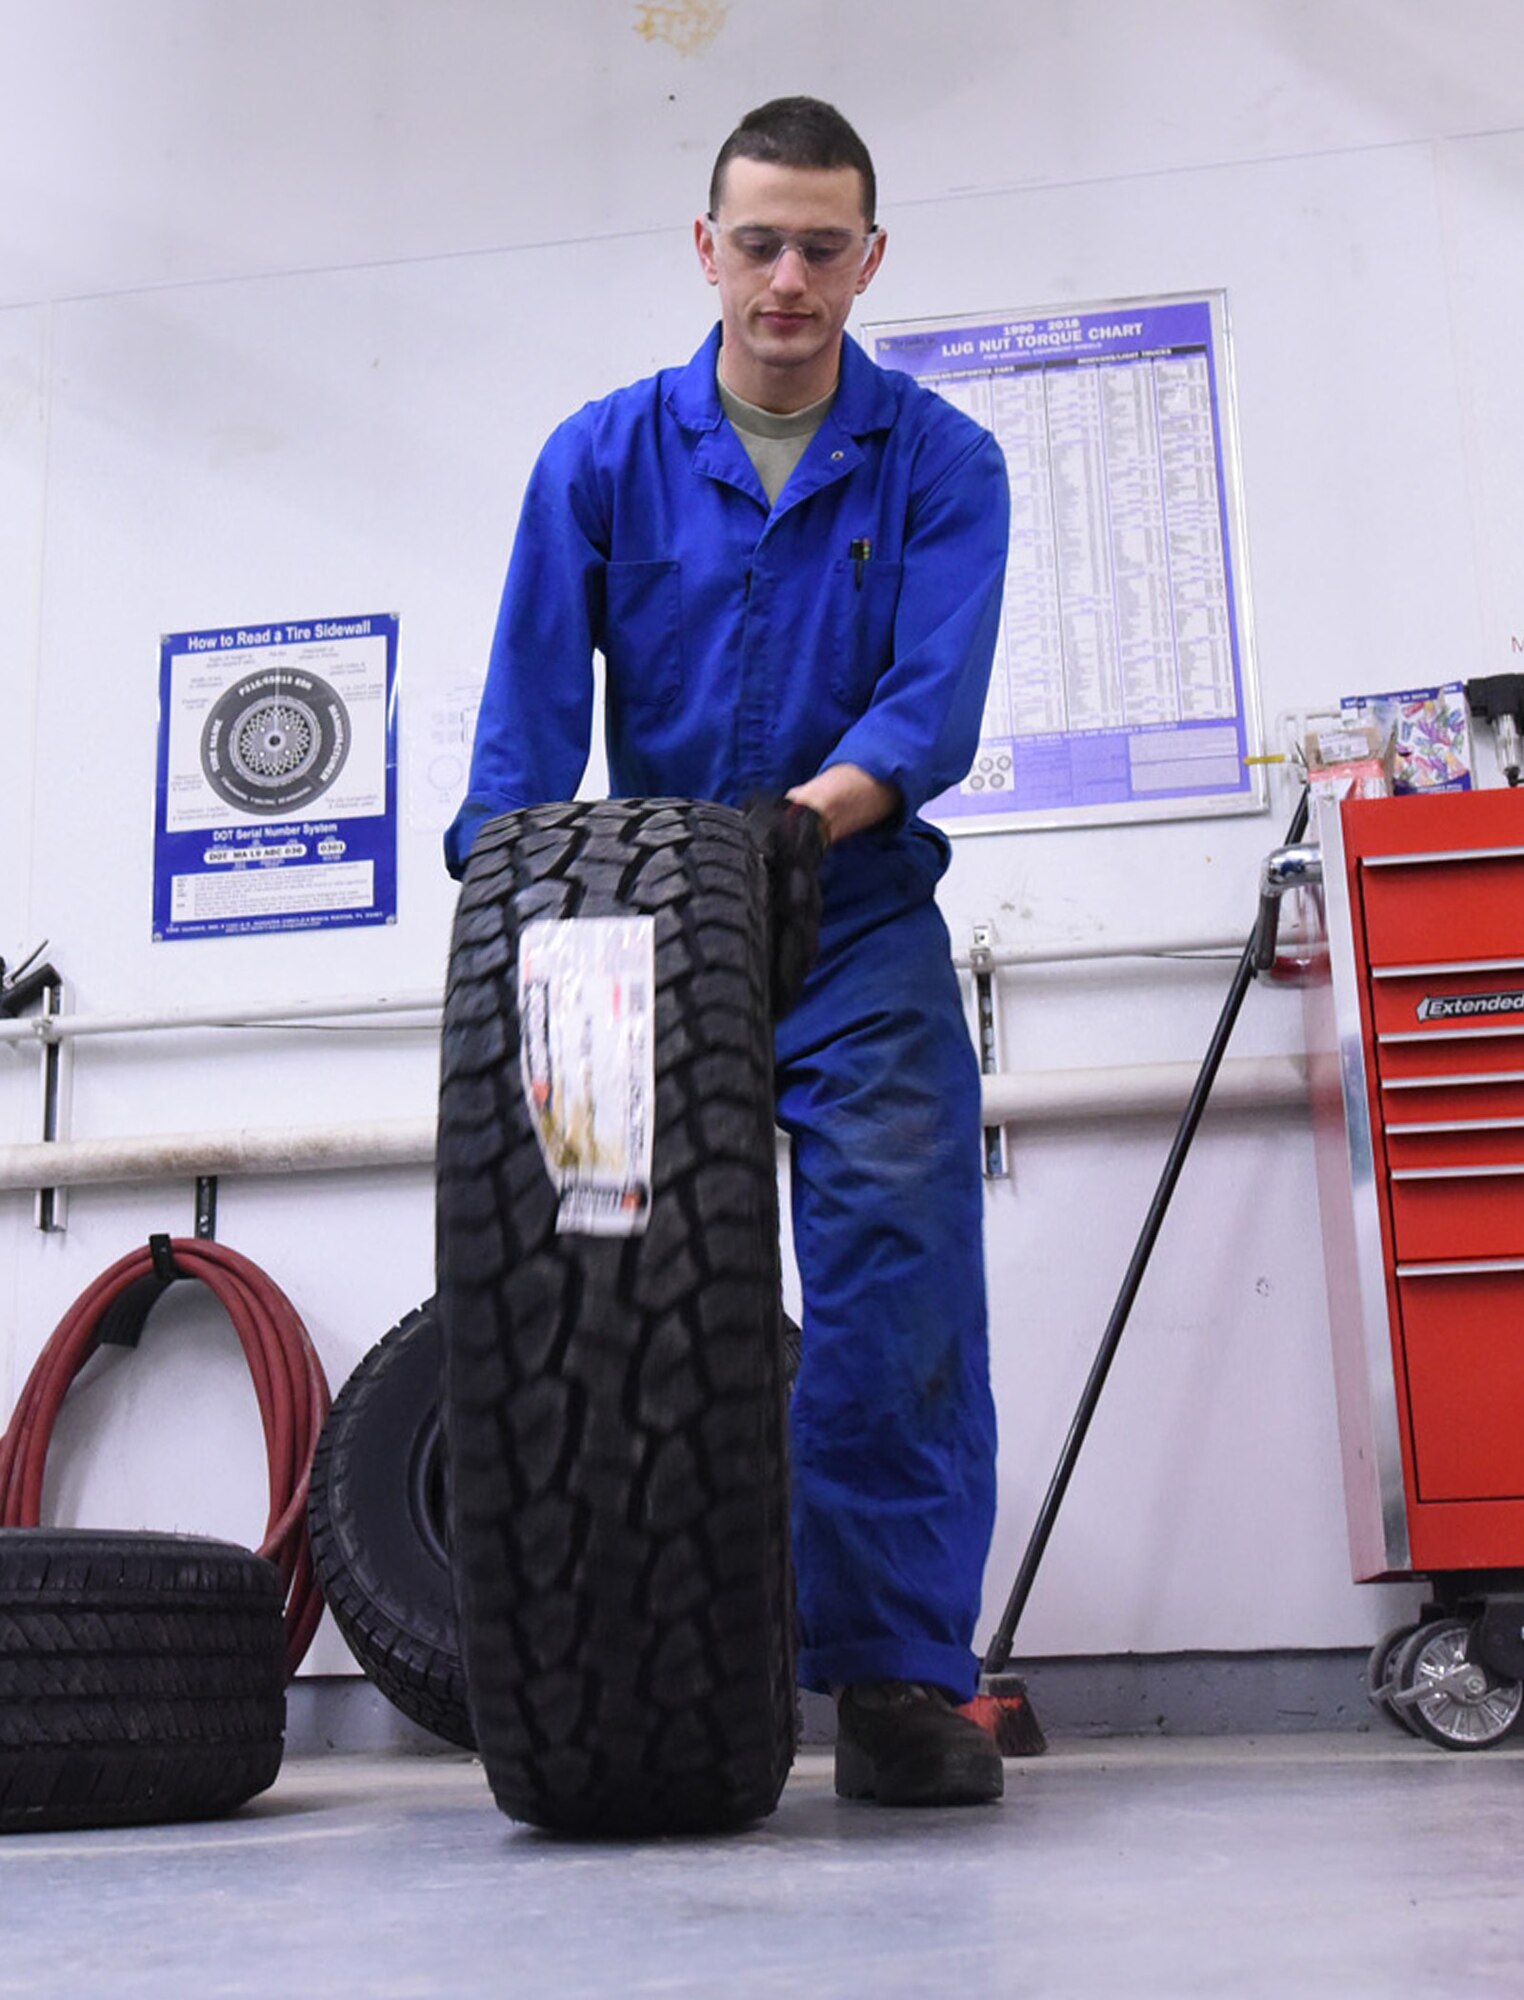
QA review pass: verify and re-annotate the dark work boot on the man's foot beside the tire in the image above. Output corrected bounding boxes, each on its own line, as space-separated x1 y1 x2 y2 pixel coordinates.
836 1680 1006 1806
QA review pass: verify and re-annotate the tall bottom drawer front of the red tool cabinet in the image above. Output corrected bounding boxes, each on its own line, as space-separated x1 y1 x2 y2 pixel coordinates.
1398 1262 1524 1500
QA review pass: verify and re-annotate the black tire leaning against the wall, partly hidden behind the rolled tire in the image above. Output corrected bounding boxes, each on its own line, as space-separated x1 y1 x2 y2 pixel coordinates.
308 1302 476 1750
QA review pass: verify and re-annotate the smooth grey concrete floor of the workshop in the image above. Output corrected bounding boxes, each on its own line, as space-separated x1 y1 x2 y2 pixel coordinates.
0 1730 1524 2000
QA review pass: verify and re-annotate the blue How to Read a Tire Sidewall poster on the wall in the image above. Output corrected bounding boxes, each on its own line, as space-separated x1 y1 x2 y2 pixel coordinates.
154 614 396 940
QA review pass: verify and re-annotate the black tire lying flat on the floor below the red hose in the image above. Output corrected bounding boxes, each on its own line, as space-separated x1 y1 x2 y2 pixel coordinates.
0 1528 286 1834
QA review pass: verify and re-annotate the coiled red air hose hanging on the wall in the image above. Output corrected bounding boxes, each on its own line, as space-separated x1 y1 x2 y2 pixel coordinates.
0 1236 328 1678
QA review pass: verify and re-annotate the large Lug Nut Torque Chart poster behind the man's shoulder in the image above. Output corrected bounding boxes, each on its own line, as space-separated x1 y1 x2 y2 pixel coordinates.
868 292 1266 832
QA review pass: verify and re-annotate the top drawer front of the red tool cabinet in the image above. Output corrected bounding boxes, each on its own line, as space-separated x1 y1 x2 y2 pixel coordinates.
1360 846 1524 966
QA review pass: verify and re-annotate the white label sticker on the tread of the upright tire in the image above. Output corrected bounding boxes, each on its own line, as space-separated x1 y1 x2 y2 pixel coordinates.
518 916 656 1236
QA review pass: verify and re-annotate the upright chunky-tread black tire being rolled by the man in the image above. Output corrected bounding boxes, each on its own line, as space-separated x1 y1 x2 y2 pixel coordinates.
436 800 794 1834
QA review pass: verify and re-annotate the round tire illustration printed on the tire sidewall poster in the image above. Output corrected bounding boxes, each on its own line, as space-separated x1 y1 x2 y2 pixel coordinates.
202 668 350 814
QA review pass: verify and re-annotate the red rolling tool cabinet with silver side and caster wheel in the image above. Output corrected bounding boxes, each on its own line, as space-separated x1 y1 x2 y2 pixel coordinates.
1308 792 1524 1748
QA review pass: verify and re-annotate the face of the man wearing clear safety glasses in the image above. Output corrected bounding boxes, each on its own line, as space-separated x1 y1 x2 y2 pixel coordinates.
694 160 884 412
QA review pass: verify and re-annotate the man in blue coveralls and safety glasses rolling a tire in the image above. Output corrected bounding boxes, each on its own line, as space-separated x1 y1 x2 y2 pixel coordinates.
446 98 1010 1806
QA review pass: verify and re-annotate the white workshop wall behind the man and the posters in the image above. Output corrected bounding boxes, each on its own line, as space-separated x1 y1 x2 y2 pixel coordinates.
0 0 1524 1668
